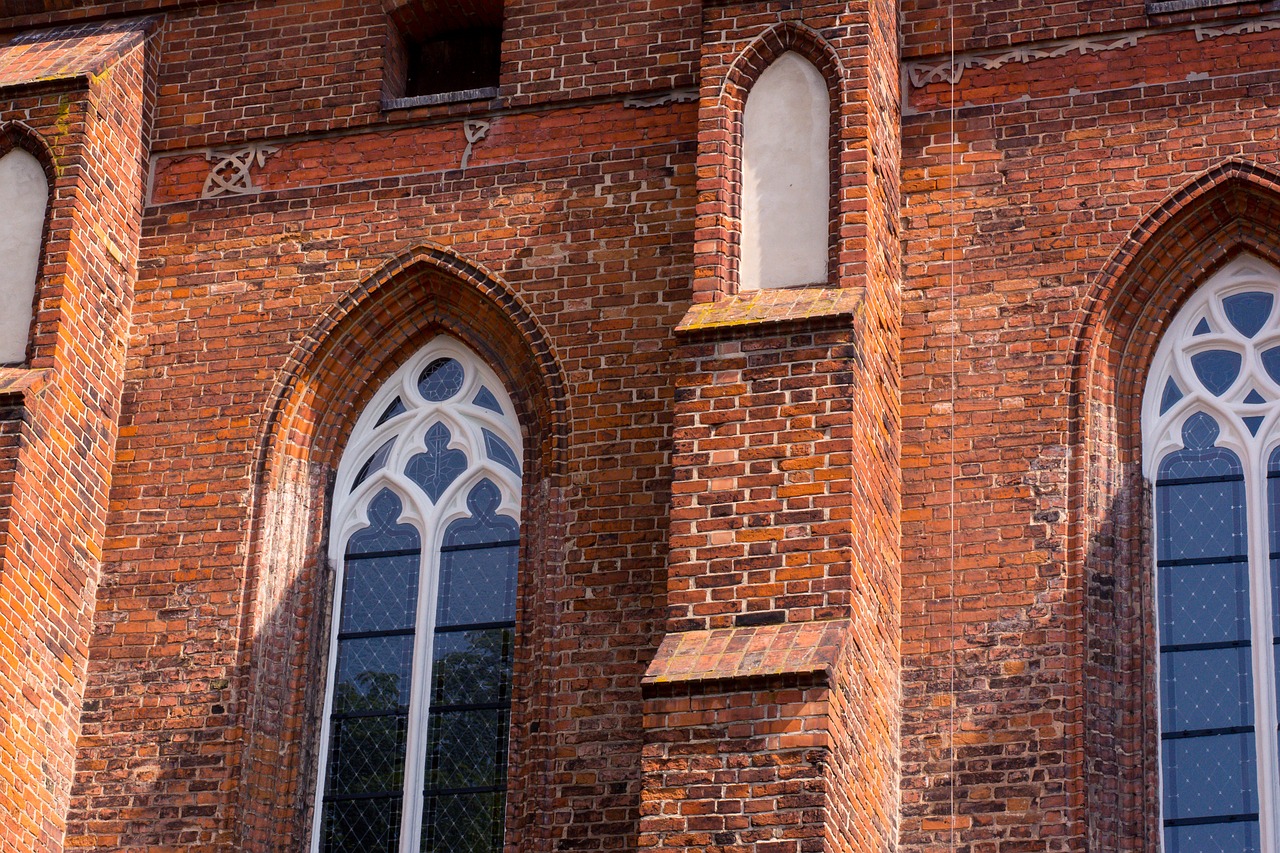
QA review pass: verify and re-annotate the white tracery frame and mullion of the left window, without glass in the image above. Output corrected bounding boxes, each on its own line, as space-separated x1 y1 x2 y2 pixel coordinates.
310 336 524 853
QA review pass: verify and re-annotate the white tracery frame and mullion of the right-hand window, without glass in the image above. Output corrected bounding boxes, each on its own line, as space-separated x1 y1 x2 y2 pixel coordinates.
1142 254 1280 850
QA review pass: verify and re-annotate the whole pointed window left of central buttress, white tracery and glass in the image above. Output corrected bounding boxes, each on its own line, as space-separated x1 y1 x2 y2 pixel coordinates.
312 337 522 853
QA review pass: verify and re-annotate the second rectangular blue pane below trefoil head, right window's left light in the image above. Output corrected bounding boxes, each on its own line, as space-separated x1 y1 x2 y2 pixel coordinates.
1157 562 1249 646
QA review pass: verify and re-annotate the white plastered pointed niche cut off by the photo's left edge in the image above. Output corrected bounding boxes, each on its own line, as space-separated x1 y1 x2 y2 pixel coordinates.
0 149 49 364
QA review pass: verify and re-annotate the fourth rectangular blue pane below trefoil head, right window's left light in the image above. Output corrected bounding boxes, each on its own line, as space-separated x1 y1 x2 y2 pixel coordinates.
1161 731 1258 820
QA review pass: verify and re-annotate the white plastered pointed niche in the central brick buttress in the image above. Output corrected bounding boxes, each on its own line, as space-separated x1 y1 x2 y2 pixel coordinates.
739 51 831 291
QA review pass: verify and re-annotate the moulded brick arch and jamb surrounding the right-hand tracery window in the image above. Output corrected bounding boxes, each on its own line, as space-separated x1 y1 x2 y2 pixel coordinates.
1069 161 1280 852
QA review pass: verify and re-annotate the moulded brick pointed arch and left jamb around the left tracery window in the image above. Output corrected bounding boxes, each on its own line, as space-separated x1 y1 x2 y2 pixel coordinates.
236 246 568 850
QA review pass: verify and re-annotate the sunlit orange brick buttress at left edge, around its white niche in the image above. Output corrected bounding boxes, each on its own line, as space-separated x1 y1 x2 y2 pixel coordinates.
0 24 150 853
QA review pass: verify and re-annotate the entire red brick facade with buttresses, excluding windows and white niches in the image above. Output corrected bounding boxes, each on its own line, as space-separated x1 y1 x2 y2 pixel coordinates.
0 0 1280 853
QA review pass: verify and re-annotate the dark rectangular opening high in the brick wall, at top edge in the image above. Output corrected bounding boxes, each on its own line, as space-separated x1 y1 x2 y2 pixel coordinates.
389 0 503 100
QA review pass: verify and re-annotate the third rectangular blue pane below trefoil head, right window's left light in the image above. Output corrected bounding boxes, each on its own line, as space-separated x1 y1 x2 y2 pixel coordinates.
1160 646 1253 734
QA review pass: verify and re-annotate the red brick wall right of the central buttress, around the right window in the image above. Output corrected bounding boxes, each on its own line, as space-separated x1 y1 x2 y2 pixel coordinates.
901 6 1280 850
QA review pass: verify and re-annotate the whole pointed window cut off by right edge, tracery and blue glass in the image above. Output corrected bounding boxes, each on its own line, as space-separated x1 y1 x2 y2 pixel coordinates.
1142 255 1280 853
